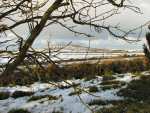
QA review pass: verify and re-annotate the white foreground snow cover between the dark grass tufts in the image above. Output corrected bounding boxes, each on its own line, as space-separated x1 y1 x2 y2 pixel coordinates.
0 72 146 113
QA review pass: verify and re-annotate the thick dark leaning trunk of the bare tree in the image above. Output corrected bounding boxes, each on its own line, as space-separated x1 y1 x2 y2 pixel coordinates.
2 0 63 76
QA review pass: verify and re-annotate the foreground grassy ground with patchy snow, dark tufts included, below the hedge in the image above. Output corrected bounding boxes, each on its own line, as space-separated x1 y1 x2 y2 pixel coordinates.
0 72 149 113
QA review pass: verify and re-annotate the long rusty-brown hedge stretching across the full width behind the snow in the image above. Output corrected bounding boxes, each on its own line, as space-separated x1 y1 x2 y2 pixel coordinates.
0 58 150 86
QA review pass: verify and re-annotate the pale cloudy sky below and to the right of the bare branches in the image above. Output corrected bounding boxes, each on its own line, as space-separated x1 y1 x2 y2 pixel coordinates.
2 0 150 50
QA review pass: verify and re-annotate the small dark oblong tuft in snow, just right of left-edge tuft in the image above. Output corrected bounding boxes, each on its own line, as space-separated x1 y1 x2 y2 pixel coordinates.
11 91 34 98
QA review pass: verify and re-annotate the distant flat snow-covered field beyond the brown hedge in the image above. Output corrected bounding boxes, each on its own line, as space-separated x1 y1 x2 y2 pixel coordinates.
0 52 143 64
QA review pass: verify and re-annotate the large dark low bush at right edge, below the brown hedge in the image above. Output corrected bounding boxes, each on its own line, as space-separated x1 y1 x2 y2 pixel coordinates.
118 76 150 101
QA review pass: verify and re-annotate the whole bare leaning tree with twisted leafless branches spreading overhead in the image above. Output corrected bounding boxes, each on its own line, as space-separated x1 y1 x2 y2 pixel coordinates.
0 0 144 75
